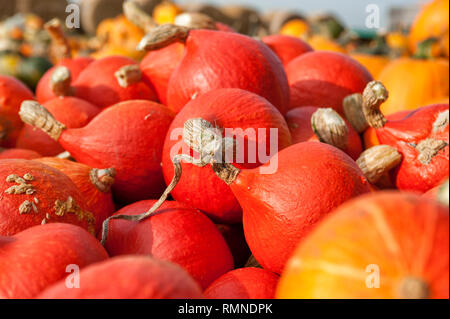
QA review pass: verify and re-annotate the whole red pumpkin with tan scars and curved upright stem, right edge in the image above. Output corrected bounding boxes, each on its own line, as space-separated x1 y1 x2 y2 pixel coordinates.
363 81 449 193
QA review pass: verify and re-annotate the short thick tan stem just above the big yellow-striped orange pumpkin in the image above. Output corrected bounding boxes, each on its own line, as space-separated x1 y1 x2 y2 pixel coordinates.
356 145 402 184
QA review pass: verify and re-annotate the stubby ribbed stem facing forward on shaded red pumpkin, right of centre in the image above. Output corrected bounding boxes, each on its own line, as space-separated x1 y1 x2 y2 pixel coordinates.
311 108 348 150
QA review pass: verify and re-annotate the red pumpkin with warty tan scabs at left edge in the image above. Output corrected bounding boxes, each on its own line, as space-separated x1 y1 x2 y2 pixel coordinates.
0 159 95 236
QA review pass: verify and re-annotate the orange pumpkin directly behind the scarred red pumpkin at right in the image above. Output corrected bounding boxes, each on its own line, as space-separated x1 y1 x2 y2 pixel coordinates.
378 58 449 115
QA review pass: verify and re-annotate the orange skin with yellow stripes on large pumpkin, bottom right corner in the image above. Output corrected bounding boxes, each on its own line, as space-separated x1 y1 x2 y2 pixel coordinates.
276 192 449 299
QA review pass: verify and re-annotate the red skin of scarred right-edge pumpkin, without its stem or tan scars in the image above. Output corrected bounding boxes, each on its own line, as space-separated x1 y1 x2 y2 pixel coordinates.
376 104 449 193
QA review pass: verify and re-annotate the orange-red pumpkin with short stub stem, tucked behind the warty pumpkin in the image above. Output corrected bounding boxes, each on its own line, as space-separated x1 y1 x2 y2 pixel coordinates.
36 157 116 233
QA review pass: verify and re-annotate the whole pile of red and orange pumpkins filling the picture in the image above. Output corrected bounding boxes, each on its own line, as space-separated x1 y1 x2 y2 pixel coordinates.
0 0 449 299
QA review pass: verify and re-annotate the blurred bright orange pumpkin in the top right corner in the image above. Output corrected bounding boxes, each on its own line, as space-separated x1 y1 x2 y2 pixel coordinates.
409 0 449 52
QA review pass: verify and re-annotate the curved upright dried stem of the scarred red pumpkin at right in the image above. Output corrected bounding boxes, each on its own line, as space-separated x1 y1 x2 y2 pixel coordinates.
362 81 389 129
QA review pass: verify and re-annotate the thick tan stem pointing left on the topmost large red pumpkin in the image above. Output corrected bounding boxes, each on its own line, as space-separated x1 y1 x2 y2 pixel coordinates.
137 24 191 51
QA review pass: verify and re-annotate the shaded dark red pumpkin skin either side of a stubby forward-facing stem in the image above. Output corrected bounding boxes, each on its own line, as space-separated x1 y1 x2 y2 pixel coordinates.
285 106 363 161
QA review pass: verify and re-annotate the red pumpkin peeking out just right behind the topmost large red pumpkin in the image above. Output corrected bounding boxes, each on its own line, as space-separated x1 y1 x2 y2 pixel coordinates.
261 34 314 66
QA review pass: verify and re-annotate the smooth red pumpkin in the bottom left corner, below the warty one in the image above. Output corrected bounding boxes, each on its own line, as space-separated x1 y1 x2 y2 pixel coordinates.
0 223 108 299
